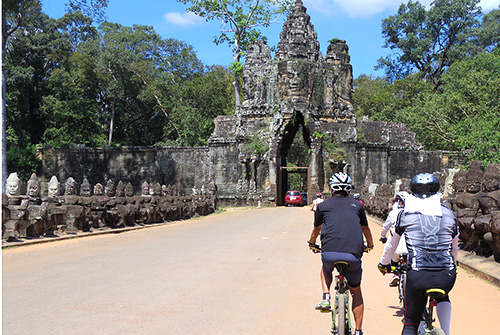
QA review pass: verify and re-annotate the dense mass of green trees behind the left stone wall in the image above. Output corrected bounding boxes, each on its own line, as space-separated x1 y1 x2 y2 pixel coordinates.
3 0 234 175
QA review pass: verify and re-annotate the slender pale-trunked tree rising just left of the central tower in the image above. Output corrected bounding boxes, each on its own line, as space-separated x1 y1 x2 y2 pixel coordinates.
177 0 292 106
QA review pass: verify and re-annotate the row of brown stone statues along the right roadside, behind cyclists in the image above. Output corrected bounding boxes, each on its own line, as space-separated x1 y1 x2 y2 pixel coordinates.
361 162 500 262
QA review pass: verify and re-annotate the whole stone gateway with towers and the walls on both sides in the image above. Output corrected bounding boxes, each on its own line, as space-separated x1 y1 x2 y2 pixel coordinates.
38 0 463 206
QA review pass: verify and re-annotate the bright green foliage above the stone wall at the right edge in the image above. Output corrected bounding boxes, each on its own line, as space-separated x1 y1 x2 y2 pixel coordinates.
353 48 500 164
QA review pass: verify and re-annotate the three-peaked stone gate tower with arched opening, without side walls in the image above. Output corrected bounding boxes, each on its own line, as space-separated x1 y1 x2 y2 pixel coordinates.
209 0 356 204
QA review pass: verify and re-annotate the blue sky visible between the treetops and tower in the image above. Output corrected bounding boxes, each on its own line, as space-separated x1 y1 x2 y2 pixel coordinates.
42 0 500 78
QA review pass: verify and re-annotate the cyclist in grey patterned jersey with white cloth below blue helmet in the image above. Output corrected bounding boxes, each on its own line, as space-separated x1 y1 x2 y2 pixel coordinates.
378 173 459 335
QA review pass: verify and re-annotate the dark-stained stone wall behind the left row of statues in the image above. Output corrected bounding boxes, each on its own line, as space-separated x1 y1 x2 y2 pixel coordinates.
37 147 209 194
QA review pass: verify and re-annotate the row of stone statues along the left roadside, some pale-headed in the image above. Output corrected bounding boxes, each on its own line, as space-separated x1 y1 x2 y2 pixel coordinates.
2 173 217 241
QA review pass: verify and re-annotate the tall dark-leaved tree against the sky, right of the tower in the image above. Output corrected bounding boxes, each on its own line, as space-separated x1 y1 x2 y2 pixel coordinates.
378 0 482 88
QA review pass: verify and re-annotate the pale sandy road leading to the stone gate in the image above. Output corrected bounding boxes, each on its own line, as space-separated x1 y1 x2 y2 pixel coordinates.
2 207 500 335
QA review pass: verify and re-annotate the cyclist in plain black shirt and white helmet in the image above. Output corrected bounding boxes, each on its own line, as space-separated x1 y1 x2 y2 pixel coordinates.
308 172 373 335
